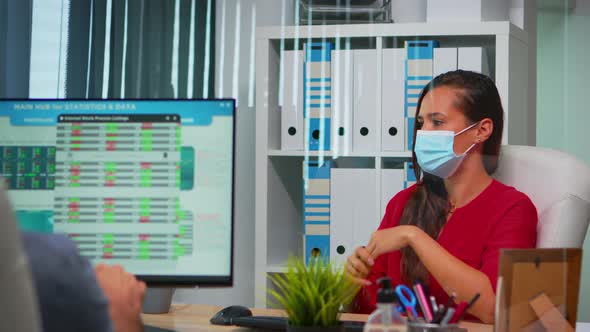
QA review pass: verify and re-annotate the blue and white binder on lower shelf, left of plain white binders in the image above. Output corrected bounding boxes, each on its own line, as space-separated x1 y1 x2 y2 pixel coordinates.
303 161 331 263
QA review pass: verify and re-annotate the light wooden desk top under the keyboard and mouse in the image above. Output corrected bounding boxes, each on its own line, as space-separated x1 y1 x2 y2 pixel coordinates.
142 304 493 332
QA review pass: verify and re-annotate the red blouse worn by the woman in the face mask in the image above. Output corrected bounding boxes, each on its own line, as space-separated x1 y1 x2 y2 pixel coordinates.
355 180 537 313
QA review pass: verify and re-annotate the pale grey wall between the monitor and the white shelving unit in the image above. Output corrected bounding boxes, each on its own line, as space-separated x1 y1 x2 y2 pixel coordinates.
174 0 294 306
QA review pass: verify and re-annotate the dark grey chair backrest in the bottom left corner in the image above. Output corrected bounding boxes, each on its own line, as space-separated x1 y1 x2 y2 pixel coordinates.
0 182 41 332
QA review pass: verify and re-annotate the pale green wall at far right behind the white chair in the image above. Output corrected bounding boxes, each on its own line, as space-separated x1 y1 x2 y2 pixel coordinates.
537 0 590 322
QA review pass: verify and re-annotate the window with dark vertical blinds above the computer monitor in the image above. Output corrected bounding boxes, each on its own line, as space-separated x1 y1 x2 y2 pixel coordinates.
0 0 215 98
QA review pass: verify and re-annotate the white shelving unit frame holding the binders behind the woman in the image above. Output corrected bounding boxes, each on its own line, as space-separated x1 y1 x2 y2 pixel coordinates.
255 22 535 307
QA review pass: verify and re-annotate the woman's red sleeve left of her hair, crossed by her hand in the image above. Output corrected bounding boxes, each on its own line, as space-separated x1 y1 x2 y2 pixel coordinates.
353 187 413 314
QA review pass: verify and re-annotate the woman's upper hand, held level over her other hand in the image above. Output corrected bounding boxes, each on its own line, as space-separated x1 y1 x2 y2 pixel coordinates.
366 225 420 257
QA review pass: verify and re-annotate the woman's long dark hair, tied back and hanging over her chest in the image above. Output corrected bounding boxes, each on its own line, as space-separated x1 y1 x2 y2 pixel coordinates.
400 70 504 283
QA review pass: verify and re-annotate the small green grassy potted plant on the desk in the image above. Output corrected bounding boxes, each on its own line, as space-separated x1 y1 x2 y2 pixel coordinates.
269 258 359 332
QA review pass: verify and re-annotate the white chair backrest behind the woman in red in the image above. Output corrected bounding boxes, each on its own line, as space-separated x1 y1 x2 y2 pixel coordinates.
494 145 590 248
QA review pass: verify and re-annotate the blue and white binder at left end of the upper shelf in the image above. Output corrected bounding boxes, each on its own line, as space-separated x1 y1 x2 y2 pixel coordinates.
303 43 332 151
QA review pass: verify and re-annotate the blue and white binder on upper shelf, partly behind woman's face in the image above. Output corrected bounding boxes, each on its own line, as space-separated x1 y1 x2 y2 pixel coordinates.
404 40 438 151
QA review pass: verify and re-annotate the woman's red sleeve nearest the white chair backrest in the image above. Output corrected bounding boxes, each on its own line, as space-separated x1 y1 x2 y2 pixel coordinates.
481 197 537 293
